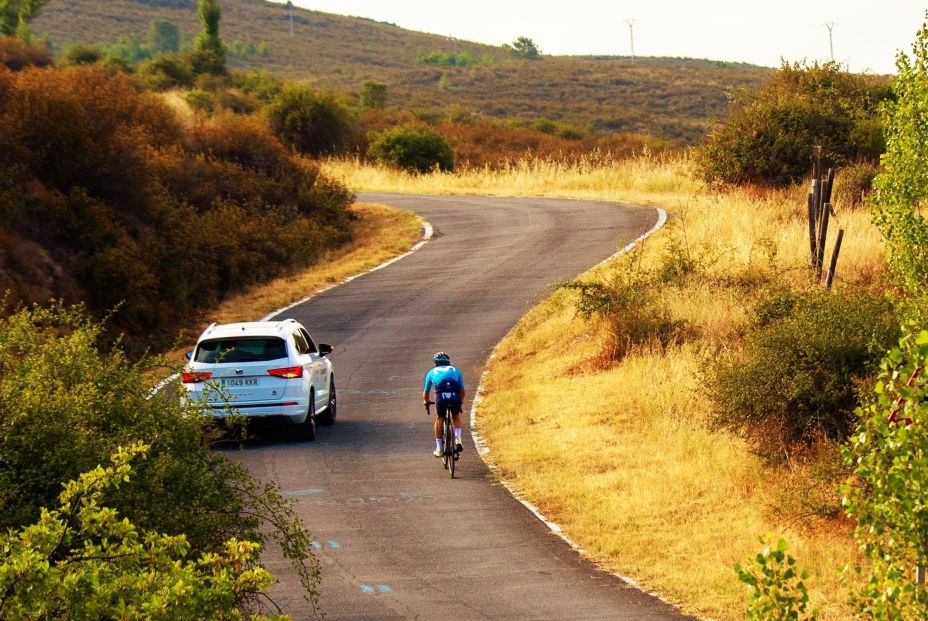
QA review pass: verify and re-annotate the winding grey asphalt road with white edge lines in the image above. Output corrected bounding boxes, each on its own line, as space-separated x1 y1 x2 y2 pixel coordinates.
238 194 683 621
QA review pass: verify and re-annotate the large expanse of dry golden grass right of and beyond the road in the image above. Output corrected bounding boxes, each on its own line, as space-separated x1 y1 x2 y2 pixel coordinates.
325 156 882 619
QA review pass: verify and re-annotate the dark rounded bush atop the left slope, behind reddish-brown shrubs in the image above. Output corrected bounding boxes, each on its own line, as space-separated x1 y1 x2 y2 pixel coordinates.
265 85 351 155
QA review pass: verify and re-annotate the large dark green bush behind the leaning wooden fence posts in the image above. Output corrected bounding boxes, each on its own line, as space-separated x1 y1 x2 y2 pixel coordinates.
699 63 891 186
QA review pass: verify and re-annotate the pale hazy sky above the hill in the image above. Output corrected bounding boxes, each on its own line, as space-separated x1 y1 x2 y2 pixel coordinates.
294 0 928 73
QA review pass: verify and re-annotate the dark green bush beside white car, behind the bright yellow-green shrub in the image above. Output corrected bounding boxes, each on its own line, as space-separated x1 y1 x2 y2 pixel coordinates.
0 305 318 612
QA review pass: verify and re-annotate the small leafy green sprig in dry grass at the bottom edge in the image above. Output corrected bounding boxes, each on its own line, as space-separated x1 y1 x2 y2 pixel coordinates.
735 539 818 621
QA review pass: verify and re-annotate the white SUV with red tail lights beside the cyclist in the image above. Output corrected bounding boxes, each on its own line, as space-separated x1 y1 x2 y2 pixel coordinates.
182 319 338 440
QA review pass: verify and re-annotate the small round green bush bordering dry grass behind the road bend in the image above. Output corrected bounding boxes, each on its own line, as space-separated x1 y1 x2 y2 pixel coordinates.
367 124 454 173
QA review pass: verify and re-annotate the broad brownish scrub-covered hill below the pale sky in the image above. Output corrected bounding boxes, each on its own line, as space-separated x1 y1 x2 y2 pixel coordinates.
33 0 770 144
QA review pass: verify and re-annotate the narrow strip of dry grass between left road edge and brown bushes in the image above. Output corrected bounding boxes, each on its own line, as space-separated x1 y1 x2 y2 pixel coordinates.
168 203 422 363
